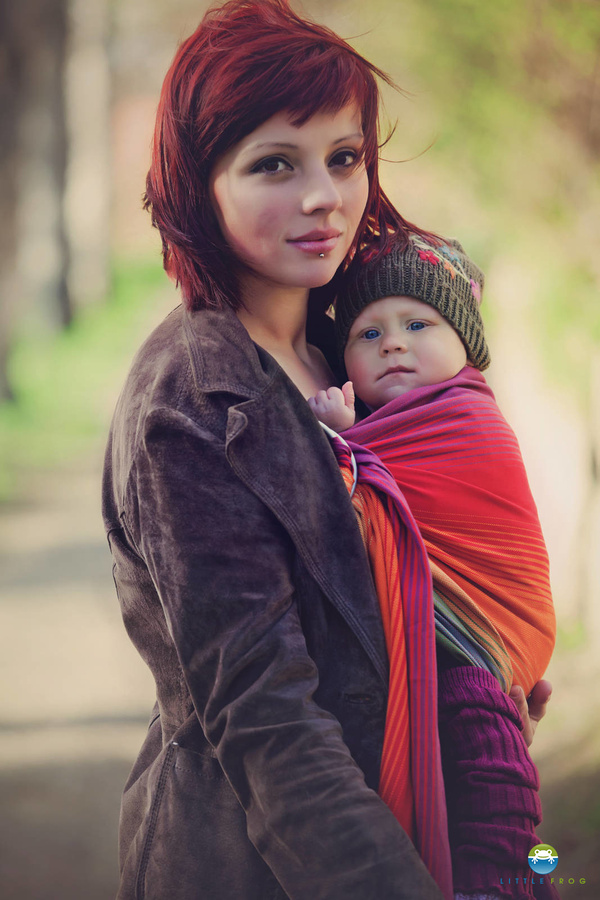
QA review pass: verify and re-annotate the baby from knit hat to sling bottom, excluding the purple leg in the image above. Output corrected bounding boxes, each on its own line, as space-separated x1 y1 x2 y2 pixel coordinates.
308 235 555 693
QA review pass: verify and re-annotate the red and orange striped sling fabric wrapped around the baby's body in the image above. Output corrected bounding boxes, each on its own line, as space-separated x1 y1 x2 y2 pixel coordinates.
344 367 556 693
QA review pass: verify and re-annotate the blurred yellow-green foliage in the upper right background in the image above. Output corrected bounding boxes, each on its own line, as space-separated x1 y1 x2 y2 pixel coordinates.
356 0 600 398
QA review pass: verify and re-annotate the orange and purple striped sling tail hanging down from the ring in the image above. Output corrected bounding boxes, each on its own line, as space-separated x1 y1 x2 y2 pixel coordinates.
326 429 453 900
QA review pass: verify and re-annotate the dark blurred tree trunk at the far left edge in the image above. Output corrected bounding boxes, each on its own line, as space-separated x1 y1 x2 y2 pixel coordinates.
0 0 72 400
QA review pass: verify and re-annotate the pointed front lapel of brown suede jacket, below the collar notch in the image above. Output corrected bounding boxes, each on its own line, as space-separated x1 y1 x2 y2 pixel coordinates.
226 371 387 684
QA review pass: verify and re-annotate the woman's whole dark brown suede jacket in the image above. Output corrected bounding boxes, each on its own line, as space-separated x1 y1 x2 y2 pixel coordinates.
103 307 441 900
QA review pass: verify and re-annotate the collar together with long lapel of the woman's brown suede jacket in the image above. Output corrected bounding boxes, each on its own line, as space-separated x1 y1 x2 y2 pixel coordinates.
183 309 388 684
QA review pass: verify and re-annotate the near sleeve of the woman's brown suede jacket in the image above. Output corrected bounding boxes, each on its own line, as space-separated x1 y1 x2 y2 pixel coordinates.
125 409 441 900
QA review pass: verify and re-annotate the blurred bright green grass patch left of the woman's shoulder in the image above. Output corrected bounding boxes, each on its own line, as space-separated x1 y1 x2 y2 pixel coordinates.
0 262 168 500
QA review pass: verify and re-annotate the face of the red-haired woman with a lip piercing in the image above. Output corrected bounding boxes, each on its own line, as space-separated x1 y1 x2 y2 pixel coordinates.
210 105 369 288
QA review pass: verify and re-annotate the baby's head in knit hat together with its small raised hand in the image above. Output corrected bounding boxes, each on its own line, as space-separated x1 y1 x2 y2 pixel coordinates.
308 237 490 431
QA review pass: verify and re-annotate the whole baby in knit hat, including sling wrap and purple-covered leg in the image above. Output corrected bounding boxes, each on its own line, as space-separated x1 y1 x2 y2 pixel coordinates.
308 235 555 897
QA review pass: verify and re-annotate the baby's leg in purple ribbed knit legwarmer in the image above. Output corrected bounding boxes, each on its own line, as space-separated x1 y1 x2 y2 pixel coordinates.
438 652 558 900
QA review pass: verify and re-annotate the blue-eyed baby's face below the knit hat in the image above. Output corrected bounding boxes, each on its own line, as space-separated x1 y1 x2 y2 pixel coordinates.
344 297 467 409
